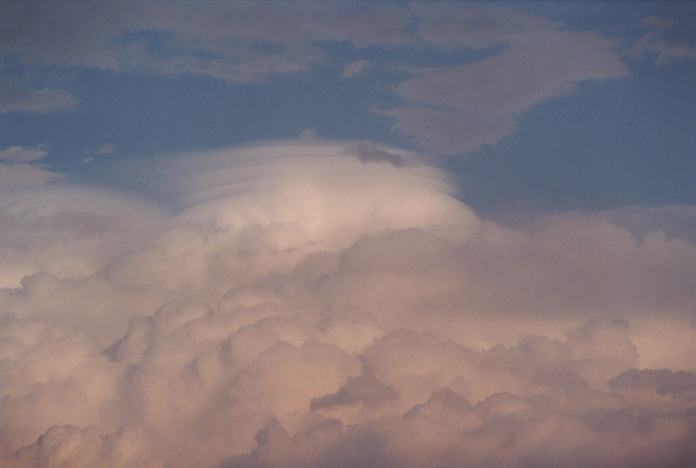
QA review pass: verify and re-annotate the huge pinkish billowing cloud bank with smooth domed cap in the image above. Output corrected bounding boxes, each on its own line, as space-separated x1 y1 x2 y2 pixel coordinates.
0 141 696 468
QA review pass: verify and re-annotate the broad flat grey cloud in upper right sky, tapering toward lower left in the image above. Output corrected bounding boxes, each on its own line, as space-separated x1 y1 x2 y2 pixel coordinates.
380 5 628 154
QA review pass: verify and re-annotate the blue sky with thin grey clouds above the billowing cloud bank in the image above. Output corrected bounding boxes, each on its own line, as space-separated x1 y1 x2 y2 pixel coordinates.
0 1 696 213
